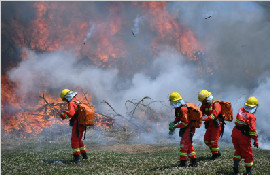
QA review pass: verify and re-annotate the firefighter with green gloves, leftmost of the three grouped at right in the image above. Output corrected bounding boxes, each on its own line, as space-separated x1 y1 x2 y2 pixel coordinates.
169 92 198 167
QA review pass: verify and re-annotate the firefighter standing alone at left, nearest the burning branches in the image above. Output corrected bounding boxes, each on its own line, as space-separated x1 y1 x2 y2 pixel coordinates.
60 89 88 163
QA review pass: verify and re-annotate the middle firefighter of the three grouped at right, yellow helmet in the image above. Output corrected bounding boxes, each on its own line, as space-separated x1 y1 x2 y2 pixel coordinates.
198 90 222 160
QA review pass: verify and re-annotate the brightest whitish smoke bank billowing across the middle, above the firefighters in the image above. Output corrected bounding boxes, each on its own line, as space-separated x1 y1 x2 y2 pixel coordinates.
9 49 203 112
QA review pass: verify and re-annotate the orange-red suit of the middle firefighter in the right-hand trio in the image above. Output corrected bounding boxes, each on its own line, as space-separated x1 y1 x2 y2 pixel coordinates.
200 102 222 155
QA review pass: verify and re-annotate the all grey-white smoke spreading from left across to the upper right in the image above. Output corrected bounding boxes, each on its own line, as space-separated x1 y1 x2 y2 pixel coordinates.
3 2 270 149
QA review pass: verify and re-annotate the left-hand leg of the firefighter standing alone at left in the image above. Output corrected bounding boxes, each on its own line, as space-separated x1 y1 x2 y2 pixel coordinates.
71 121 81 163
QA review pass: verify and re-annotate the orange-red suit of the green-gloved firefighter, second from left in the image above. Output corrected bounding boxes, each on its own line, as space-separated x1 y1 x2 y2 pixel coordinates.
173 107 196 160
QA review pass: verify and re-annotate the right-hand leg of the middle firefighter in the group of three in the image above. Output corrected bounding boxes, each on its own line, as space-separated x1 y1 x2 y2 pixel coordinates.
211 126 221 160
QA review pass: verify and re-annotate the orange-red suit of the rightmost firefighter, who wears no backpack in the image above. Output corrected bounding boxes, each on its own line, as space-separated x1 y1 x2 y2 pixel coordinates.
232 107 258 167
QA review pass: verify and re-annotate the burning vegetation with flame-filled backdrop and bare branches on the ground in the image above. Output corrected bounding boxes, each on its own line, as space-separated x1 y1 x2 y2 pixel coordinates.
1 1 213 137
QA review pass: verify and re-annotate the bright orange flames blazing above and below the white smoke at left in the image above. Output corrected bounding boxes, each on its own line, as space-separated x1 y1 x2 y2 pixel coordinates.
1 1 207 137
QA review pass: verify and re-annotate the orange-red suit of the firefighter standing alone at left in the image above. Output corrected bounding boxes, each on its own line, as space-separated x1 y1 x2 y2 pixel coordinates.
61 97 87 155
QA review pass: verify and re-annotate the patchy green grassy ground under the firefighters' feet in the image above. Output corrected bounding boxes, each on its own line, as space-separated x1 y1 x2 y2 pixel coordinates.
1 141 270 175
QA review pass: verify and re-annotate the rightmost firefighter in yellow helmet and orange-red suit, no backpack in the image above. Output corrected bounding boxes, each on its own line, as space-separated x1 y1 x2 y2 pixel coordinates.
232 96 259 174
